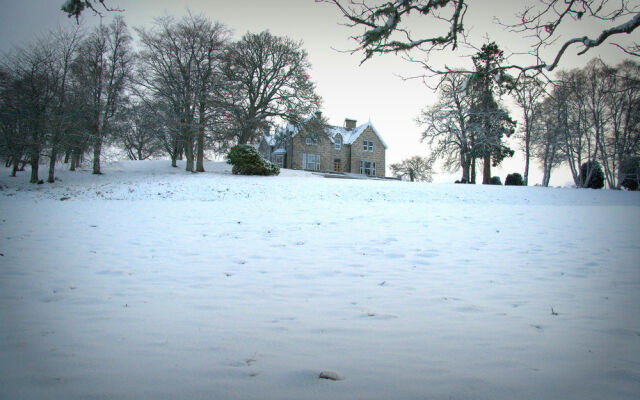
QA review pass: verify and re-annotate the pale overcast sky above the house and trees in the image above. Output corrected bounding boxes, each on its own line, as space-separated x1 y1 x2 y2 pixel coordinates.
0 0 636 185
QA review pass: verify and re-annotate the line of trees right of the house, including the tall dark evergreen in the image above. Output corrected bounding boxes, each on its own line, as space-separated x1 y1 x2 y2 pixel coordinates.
418 43 640 188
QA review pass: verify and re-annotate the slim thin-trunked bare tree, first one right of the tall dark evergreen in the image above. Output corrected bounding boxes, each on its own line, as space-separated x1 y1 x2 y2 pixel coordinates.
511 74 546 186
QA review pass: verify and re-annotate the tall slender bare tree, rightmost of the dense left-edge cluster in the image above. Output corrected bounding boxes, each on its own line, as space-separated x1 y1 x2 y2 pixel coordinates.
74 16 132 174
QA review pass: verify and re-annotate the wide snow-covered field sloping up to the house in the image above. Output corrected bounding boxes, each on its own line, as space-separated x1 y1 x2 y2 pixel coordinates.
0 161 640 400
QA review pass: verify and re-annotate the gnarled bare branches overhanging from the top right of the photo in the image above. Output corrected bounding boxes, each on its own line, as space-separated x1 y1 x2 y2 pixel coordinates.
324 0 640 74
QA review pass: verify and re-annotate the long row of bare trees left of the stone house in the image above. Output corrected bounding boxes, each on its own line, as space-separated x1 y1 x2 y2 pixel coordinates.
0 14 321 183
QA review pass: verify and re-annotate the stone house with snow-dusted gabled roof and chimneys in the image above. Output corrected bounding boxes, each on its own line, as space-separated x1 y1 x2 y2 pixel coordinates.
258 112 387 178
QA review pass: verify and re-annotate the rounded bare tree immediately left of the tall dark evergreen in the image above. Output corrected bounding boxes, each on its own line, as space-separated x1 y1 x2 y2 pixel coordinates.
418 73 475 182
